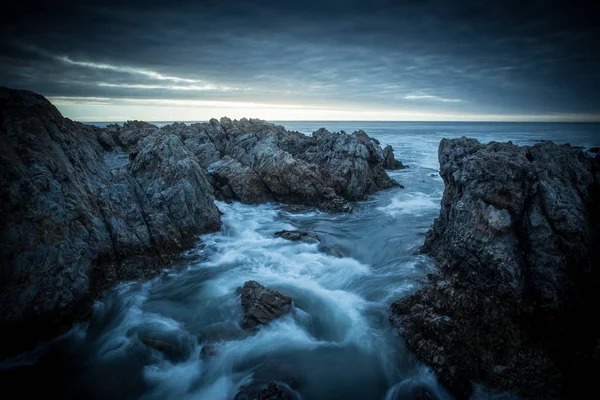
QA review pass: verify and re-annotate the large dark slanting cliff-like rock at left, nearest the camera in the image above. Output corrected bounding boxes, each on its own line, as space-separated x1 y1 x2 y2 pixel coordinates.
0 88 220 356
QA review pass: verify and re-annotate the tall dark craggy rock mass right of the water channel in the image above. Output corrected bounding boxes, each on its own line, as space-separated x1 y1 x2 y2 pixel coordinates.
391 138 600 398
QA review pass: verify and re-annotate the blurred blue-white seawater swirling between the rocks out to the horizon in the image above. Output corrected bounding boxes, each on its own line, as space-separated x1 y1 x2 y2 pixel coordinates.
0 122 600 400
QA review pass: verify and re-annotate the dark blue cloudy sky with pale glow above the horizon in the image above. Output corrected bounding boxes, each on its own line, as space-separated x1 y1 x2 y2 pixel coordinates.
0 0 600 122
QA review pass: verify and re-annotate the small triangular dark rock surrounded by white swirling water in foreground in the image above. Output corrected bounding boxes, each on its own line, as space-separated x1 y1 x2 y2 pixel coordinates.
238 281 292 330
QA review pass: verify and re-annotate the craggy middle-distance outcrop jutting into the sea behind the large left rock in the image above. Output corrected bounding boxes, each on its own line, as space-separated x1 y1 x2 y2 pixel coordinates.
155 118 400 212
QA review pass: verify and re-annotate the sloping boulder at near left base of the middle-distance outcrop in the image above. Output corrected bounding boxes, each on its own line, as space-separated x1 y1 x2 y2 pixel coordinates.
208 156 273 204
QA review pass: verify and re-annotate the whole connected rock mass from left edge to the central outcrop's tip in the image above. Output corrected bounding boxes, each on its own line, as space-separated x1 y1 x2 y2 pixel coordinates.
0 88 403 357
